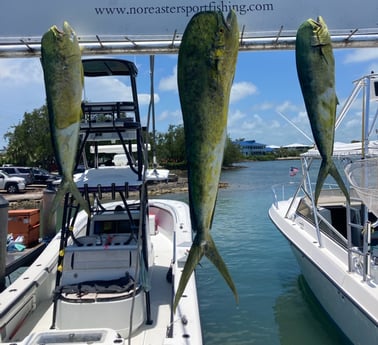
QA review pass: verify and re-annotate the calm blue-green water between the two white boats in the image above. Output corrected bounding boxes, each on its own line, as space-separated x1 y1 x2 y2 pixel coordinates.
165 161 349 345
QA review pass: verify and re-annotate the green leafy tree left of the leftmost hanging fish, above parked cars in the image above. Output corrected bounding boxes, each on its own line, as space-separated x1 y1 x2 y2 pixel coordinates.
4 105 54 169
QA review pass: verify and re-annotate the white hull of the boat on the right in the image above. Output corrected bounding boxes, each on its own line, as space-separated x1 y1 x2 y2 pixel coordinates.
269 202 378 345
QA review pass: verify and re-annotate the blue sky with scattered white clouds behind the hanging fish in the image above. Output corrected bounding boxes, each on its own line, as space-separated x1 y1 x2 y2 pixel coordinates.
0 48 378 149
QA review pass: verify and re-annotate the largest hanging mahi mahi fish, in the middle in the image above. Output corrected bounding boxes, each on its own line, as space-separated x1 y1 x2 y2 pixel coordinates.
174 11 239 309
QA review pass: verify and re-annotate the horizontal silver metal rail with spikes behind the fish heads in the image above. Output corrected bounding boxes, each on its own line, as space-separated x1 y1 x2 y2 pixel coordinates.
0 25 378 58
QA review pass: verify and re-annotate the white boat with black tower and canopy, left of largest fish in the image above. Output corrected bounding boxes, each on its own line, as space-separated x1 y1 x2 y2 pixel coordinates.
0 58 202 345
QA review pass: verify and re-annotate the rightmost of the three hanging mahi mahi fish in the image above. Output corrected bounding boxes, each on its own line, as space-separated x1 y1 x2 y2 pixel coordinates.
295 16 349 204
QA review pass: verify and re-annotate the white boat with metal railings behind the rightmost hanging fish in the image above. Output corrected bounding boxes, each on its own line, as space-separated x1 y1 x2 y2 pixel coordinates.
269 74 378 344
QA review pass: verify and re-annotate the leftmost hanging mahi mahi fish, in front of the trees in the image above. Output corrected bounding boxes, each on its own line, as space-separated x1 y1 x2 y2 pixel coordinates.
41 22 89 213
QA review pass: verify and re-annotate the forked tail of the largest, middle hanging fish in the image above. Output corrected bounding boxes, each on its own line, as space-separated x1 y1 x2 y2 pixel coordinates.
173 234 239 311
